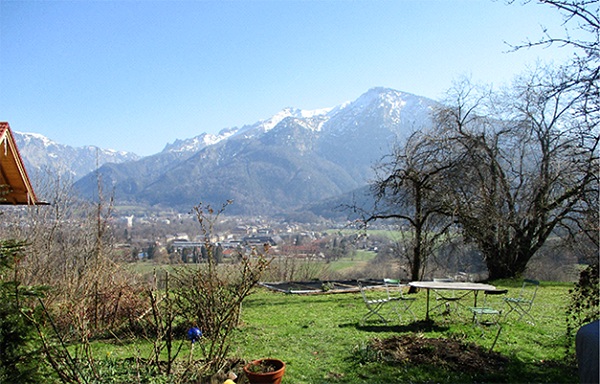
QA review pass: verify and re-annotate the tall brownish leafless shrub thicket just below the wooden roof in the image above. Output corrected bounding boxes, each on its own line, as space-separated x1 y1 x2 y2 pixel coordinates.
2 170 144 344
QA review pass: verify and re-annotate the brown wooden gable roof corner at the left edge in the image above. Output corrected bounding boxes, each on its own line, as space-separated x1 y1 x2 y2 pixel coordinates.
0 122 46 205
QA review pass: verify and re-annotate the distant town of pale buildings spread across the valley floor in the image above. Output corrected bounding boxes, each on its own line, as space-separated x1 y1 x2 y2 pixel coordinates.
113 210 382 263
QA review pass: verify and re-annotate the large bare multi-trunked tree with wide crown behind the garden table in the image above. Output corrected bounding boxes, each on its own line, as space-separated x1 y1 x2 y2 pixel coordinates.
431 69 598 279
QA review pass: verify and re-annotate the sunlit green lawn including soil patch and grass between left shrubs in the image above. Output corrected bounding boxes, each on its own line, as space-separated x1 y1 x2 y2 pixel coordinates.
81 281 578 384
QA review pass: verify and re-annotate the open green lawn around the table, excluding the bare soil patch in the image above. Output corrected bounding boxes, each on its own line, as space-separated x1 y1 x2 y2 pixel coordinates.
225 281 578 384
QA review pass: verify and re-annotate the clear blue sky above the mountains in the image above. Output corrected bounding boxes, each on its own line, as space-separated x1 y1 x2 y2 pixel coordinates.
0 0 572 155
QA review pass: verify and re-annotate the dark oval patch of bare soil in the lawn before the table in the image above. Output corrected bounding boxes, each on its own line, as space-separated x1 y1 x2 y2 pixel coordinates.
371 334 508 374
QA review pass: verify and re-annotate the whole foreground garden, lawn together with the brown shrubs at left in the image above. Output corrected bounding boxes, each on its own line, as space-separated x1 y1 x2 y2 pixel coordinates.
0 195 598 384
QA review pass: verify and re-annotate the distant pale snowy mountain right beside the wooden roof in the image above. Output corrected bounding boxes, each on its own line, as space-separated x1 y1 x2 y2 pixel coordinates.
13 131 140 182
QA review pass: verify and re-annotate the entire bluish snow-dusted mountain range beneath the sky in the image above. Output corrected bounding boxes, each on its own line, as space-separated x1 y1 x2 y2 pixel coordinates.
17 87 435 216
